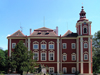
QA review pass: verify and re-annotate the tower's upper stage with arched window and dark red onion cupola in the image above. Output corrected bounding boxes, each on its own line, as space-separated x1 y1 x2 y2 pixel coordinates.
76 6 92 35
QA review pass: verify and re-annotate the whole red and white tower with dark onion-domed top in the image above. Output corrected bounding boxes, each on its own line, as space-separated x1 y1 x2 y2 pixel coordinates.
76 6 92 75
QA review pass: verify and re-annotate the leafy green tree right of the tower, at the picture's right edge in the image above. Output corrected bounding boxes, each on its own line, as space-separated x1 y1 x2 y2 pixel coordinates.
92 31 100 73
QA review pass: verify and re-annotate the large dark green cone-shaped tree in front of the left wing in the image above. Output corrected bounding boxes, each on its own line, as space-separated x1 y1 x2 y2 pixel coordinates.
9 41 38 74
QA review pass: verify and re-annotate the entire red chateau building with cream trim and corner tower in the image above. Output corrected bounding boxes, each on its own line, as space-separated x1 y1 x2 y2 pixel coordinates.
7 7 93 75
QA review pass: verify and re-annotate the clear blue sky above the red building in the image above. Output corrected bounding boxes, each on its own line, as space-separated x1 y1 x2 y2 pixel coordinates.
0 0 100 50
